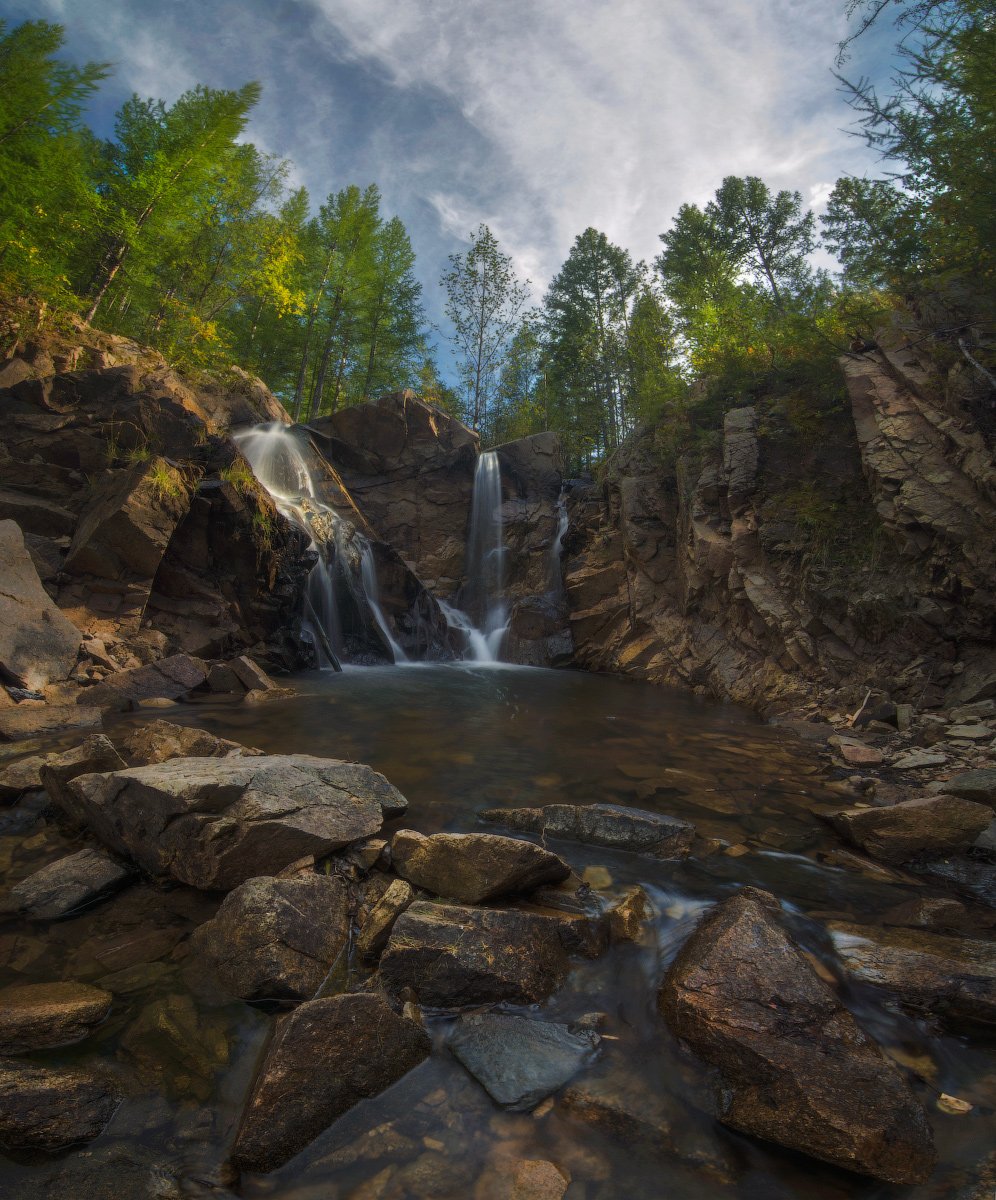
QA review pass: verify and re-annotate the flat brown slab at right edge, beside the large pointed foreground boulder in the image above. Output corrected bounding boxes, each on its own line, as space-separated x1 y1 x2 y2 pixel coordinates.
827 922 996 1026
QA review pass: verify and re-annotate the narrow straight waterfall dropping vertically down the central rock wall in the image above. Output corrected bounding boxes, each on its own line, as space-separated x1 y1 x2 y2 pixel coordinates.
451 450 509 662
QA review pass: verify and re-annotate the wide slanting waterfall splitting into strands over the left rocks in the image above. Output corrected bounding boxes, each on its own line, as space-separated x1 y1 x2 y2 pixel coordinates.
232 422 408 670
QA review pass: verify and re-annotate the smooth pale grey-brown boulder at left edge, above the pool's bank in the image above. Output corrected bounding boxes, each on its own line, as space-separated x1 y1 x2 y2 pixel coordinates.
0 521 83 689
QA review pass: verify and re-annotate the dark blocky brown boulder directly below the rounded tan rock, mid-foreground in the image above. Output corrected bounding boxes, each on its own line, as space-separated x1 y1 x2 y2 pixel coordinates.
380 900 568 1008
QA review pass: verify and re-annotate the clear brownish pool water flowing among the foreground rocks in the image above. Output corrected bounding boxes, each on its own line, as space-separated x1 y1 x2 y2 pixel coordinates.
0 666 996 1200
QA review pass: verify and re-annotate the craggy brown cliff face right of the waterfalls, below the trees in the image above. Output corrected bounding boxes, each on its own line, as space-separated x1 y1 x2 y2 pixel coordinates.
565 314 996 712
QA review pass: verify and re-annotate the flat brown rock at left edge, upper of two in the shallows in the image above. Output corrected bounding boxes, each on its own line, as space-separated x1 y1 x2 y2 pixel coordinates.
0 983 114 1055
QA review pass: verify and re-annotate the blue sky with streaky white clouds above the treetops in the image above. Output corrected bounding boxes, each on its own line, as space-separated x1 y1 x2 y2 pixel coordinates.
0 0 892 364
